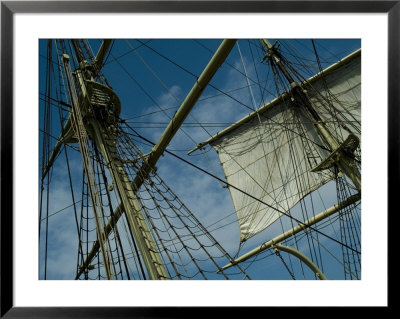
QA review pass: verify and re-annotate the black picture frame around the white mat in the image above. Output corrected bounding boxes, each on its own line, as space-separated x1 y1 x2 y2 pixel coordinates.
0 0 394 318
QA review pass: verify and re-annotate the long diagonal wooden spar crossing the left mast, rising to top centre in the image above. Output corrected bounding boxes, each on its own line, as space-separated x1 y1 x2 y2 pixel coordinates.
75 39 236 279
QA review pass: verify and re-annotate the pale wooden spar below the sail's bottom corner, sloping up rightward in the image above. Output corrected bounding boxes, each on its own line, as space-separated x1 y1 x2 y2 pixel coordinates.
217 193 361 272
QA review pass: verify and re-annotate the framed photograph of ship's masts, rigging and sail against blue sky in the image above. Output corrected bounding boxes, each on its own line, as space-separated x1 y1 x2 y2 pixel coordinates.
38 39 362 280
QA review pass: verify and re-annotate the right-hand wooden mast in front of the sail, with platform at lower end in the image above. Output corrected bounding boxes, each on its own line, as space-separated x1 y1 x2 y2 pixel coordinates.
261 39 361 192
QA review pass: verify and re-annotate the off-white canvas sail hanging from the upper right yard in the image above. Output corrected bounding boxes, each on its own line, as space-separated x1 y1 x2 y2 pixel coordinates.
208 50 361 241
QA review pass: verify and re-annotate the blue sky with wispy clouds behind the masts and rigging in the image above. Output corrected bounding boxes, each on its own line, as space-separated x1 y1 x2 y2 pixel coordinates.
39 39 361 279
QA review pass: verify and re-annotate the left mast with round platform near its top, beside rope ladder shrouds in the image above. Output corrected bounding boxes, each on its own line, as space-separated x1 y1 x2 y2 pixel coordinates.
59 40 168 279
